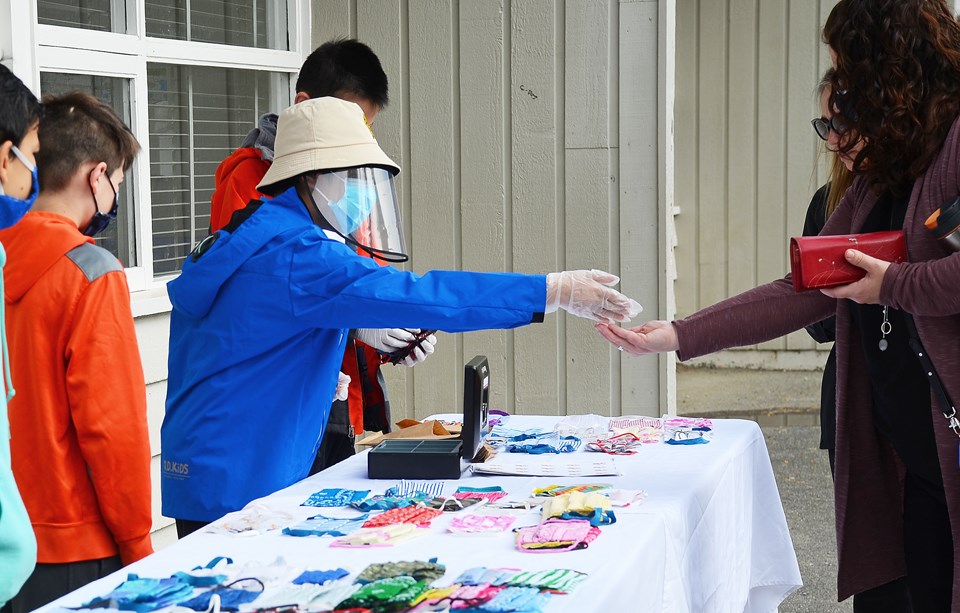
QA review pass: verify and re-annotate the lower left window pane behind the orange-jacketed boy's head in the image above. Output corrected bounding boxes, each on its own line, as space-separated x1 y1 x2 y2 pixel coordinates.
40 72 137 268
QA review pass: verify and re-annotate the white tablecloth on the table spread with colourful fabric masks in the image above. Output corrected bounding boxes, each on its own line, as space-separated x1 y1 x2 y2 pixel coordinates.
39 416 801 613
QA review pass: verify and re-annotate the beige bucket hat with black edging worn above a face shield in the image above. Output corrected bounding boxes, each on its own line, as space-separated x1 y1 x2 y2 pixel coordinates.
257 97 400 189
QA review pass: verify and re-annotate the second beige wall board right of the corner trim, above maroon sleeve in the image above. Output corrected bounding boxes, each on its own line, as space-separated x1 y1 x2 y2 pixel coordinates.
696 0 729 306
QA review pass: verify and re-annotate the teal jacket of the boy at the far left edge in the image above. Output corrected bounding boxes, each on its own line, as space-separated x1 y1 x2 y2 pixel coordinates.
0 245 37 605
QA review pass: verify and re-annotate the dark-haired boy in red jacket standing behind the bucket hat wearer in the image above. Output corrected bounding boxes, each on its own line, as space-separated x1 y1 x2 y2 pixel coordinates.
206 38 437 498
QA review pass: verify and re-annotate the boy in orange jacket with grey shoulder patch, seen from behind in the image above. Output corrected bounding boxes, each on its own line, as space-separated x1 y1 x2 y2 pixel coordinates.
0 93 153 613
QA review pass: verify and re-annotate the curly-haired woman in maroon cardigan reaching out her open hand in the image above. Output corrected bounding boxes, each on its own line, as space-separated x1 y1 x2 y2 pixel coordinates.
597 0 960 611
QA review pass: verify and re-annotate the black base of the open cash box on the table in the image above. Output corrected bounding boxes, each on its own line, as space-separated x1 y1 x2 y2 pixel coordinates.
367 439 464 479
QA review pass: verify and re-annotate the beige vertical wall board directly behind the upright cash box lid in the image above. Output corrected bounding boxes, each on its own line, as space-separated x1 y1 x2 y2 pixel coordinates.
460 0 513 409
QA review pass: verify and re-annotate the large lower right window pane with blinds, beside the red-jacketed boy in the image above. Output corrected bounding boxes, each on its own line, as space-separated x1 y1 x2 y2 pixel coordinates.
147 64 289 275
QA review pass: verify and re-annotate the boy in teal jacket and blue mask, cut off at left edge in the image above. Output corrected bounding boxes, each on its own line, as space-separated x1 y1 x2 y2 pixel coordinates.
0 65 42 606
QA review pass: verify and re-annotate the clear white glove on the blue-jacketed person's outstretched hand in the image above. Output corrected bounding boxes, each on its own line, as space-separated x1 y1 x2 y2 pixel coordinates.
546 270 643 323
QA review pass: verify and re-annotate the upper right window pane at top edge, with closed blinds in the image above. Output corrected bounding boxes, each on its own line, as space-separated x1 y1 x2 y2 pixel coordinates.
145 0 289 50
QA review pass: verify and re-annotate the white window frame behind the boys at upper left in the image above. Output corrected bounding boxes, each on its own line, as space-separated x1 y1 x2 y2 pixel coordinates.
0 0 312 316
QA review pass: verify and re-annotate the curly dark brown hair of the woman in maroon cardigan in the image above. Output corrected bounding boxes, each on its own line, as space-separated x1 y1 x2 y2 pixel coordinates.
823 0 960 195
